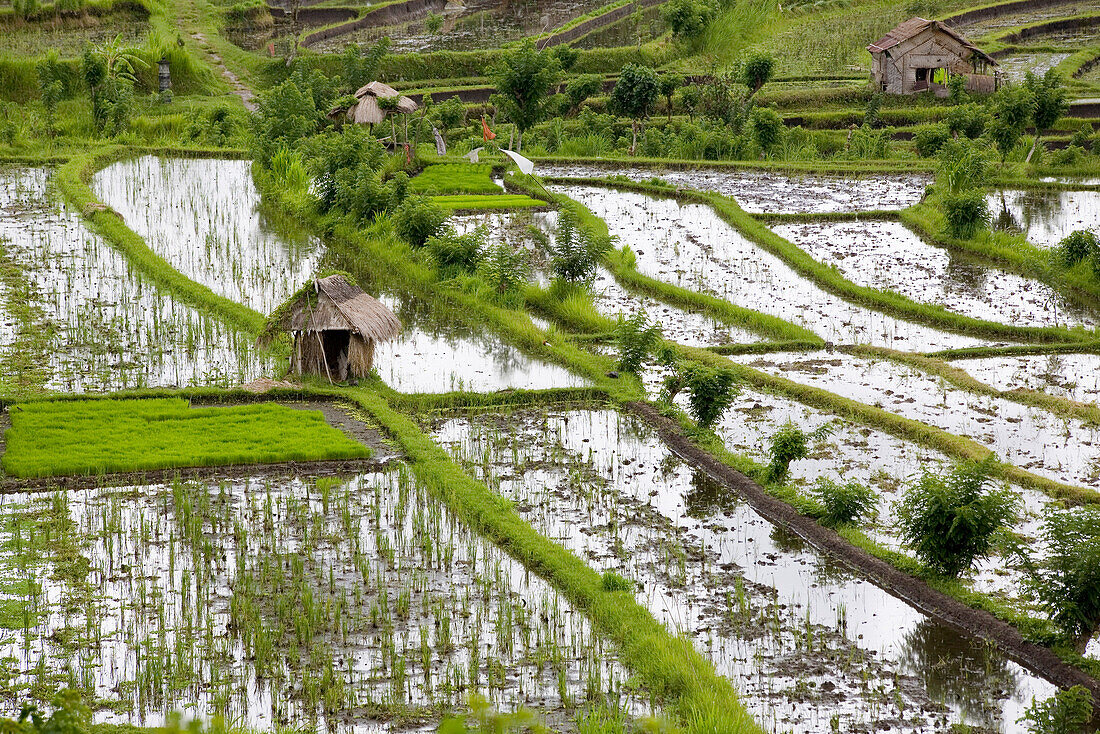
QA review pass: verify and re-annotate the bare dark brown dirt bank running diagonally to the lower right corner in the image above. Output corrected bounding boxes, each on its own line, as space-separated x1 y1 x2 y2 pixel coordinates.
626 403 1100 702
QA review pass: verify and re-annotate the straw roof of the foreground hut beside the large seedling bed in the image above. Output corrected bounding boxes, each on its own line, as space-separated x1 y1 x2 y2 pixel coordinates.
269 275 402 341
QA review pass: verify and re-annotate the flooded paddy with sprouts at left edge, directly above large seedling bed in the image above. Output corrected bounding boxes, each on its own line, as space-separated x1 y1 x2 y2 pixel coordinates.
0 168 271 392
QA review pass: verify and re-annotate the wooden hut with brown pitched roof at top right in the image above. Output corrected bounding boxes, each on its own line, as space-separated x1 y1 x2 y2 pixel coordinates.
867 18 999 97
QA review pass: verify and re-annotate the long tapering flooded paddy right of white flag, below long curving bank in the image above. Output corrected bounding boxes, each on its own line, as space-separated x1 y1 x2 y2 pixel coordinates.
556 186 1003 351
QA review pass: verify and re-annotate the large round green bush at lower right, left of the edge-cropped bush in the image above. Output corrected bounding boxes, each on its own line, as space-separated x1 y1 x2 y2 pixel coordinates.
897 456 1019 577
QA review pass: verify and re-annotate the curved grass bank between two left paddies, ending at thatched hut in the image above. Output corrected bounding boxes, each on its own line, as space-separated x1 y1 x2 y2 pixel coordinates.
54 147 265 335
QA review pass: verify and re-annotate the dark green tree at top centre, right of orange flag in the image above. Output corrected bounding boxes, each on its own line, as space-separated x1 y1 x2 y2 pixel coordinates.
491 39 561 151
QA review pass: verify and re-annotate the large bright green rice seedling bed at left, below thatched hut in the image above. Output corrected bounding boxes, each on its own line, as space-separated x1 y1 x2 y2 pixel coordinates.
3 398 371 478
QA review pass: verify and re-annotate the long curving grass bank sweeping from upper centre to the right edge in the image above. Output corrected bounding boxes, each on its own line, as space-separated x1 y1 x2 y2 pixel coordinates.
558 178 1096 343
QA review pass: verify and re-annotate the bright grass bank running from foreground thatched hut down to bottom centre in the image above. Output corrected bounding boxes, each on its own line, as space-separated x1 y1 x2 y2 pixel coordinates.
341 390 761 734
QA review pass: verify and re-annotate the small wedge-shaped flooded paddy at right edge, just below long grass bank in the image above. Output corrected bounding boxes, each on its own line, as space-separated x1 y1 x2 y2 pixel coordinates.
952 354 1100 403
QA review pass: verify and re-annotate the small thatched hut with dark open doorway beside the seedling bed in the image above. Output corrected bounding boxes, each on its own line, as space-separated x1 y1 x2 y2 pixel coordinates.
261 275 402 382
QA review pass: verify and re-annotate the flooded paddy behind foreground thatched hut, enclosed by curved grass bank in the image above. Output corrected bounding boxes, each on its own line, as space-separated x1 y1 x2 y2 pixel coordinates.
91 155 322 314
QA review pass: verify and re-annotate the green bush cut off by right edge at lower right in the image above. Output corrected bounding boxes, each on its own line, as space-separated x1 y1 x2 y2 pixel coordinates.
1029 507 1100 640
